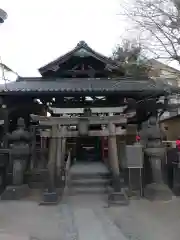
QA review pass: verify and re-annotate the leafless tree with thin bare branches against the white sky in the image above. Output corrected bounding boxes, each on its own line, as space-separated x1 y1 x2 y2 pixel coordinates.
121 0 180 64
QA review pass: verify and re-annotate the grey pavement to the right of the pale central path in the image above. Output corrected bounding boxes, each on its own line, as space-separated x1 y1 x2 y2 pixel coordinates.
107 198 180 240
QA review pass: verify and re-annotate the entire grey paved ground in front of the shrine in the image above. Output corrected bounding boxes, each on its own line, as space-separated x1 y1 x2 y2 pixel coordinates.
0 195 180 240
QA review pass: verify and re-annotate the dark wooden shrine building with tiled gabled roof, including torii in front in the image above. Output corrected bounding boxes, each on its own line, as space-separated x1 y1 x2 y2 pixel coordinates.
0 41 177 202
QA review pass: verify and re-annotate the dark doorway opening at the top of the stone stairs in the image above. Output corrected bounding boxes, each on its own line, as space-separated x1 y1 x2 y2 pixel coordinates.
76 136 101 162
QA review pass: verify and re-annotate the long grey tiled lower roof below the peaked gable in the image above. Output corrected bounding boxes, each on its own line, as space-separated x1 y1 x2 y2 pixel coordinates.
0 78 176 94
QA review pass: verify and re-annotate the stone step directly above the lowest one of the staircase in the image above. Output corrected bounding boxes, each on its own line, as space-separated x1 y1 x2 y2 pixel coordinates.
69 178 110 187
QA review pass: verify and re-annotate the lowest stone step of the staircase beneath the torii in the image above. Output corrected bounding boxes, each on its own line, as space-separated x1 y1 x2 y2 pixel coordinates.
69 187 107 195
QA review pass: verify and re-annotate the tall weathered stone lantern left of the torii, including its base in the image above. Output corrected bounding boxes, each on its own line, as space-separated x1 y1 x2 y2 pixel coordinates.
1 118 31 200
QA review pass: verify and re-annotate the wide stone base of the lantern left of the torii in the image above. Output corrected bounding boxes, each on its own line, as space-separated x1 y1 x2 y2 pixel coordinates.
1 184 29 200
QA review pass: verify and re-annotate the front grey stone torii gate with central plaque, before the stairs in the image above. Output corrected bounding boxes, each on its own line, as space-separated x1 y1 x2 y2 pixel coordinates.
31 115 127 202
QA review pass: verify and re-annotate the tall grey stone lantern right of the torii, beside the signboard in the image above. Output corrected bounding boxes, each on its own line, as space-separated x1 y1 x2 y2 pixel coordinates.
145 116 172 200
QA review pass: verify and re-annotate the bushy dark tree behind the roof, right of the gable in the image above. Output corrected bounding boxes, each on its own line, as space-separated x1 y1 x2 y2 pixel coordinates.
112 40 151 77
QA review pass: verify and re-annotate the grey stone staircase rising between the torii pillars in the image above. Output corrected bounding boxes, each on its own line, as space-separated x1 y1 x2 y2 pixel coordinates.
68 162 110 195
